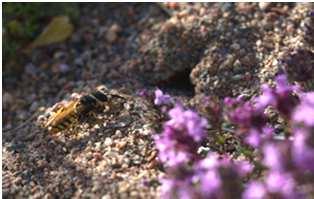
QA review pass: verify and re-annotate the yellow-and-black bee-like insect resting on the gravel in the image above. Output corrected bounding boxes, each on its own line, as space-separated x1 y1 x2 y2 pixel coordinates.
45 88 124 132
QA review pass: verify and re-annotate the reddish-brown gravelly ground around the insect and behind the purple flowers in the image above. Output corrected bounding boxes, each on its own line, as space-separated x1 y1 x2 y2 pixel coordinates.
2 3 314 198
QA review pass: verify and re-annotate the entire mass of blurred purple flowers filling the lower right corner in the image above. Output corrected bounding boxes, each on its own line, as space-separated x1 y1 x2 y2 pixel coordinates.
155 75 314 199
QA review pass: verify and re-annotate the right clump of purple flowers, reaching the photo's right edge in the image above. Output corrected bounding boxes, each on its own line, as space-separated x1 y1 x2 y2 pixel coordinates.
225 75 314 198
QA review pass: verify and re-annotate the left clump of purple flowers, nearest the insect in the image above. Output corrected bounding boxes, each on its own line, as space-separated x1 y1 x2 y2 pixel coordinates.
155 105 253 198
